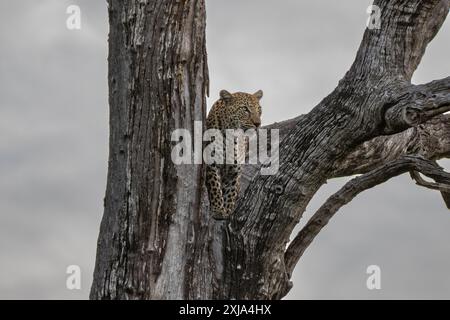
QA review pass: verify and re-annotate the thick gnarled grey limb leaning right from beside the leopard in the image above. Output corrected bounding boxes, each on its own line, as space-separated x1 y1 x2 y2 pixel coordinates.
224 0 449 299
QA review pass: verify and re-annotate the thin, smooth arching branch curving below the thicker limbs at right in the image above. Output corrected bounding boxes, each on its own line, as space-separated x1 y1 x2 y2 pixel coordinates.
285 156 450 274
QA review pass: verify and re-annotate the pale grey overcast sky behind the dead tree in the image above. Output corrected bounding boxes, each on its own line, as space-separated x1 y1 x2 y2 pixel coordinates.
0 0 450 299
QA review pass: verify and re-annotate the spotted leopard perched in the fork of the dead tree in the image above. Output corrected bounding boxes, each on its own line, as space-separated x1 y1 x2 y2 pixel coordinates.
206 90 263 220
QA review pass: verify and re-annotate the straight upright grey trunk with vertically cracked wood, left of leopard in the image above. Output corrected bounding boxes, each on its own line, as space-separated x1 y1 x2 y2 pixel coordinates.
90 0 211 299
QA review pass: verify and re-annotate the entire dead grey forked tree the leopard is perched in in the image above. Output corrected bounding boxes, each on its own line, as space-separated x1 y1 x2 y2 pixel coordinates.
91 0 450 299
